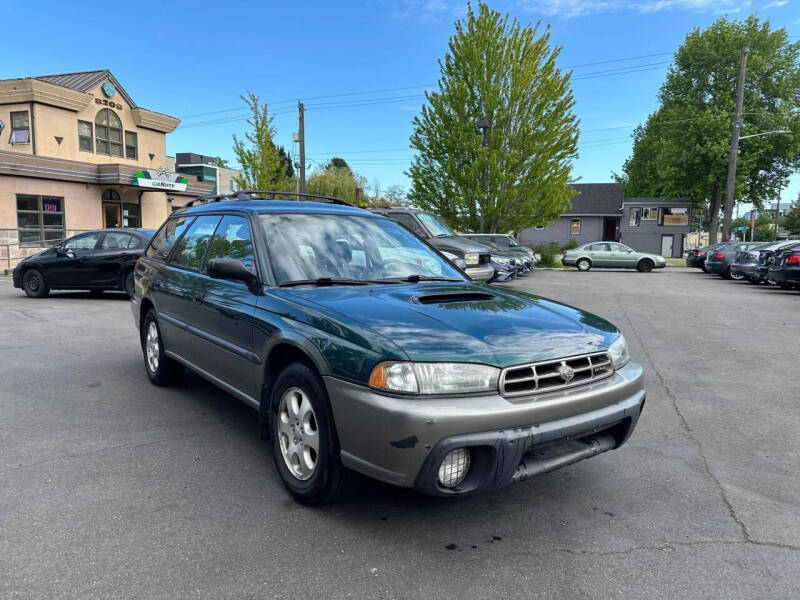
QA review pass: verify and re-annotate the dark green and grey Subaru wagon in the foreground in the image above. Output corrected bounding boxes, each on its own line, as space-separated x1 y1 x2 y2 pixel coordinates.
131 192 645 504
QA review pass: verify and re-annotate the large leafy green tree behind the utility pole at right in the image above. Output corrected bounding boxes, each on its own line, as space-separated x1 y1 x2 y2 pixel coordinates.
616 16 800 243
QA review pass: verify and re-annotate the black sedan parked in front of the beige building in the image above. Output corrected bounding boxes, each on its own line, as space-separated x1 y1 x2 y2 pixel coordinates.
13 229 155 298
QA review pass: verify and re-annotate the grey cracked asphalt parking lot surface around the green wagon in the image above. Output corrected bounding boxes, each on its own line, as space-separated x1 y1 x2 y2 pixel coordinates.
0 268 800 599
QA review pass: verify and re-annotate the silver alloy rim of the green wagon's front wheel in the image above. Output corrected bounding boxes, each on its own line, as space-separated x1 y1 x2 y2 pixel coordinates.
278 387 319 481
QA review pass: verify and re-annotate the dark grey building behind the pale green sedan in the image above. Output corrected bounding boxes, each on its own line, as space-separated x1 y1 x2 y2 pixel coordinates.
519 183 692 258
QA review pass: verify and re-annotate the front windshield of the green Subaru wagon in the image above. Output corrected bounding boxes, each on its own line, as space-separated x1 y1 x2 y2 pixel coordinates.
260 213 464 285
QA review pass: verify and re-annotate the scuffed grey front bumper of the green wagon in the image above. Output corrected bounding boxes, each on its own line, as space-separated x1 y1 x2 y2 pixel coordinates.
325 363 645 496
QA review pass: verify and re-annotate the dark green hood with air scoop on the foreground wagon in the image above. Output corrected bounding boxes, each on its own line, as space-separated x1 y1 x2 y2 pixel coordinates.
279 282 618 367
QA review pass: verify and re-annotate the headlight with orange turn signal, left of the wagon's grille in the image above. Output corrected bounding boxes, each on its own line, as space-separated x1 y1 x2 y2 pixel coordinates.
369 362 500 394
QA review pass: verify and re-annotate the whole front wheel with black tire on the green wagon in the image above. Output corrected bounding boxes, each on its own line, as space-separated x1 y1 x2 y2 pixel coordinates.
270 363 347 505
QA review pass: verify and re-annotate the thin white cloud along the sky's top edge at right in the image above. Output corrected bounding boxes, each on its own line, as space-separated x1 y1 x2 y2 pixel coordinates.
519 0 752 19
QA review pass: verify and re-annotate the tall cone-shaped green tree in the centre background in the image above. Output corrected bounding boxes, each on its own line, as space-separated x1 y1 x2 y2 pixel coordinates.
408 2 578 232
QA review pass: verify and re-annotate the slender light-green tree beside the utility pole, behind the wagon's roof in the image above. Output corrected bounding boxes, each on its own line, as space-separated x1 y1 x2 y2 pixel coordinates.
233 92 294 190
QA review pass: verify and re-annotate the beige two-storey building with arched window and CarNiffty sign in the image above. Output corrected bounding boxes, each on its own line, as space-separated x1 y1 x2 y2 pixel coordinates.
0 70 214 270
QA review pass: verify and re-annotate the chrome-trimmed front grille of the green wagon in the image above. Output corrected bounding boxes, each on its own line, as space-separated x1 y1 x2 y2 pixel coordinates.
500 352 614 396
